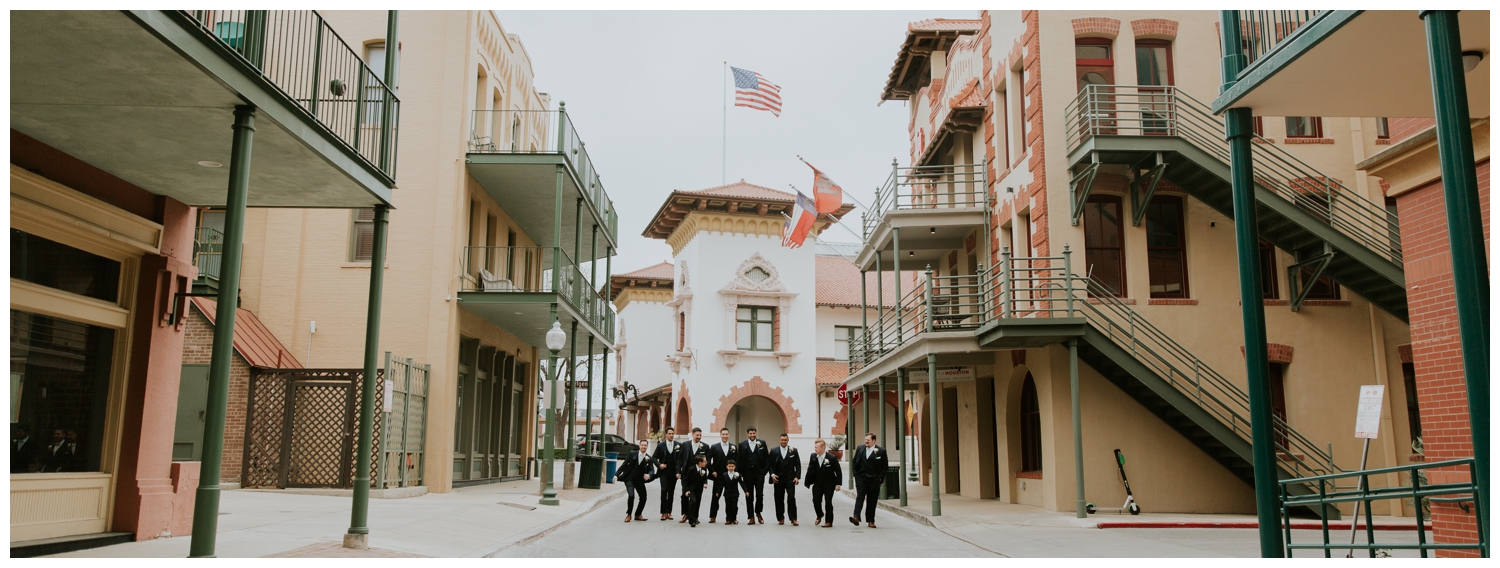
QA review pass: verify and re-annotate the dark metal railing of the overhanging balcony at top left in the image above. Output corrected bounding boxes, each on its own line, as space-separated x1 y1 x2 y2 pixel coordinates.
182 10 401 180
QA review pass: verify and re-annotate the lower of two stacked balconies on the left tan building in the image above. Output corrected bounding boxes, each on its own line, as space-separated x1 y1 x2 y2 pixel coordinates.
459 246 615 352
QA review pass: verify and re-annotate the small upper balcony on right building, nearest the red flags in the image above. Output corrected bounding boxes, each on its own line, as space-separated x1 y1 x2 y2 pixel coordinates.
855 163 989 270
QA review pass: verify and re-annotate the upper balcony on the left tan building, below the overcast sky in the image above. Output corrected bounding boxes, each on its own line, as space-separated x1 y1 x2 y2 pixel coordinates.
468 109 620 261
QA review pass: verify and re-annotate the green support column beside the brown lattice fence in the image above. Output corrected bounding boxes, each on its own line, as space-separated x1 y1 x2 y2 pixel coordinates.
344 205 390 550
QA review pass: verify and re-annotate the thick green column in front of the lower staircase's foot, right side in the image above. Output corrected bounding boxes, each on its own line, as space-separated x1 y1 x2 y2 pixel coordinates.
1220 10 1286 558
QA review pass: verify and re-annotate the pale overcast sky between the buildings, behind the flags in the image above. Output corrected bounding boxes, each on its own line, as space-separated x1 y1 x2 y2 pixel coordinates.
497 10 977 273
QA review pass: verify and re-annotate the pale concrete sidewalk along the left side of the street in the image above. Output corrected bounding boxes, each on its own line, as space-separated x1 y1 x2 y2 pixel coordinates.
57 480 624 558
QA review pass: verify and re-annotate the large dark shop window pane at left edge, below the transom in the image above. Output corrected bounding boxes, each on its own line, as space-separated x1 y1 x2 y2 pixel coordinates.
11 310 116 474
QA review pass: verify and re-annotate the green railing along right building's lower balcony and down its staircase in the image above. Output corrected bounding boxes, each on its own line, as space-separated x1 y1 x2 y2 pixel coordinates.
849 250 1341 475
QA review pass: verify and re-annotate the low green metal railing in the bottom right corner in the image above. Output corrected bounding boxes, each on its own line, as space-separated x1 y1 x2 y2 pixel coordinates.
1281 457 1490 558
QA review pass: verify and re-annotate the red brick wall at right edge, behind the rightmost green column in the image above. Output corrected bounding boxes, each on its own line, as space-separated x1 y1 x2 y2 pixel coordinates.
1392 158 1490 556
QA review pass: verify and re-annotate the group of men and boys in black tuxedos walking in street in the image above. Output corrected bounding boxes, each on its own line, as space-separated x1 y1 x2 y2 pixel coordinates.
617 427 887 529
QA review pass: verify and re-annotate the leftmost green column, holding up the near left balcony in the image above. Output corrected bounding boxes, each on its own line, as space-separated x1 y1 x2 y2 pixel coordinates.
188 105 255 558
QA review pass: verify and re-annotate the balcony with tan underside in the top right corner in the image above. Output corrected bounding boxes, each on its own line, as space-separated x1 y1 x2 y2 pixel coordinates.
1212 9 1490 118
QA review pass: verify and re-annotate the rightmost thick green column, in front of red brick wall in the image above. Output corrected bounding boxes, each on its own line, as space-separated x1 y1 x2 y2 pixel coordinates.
1421 10 1491 548
